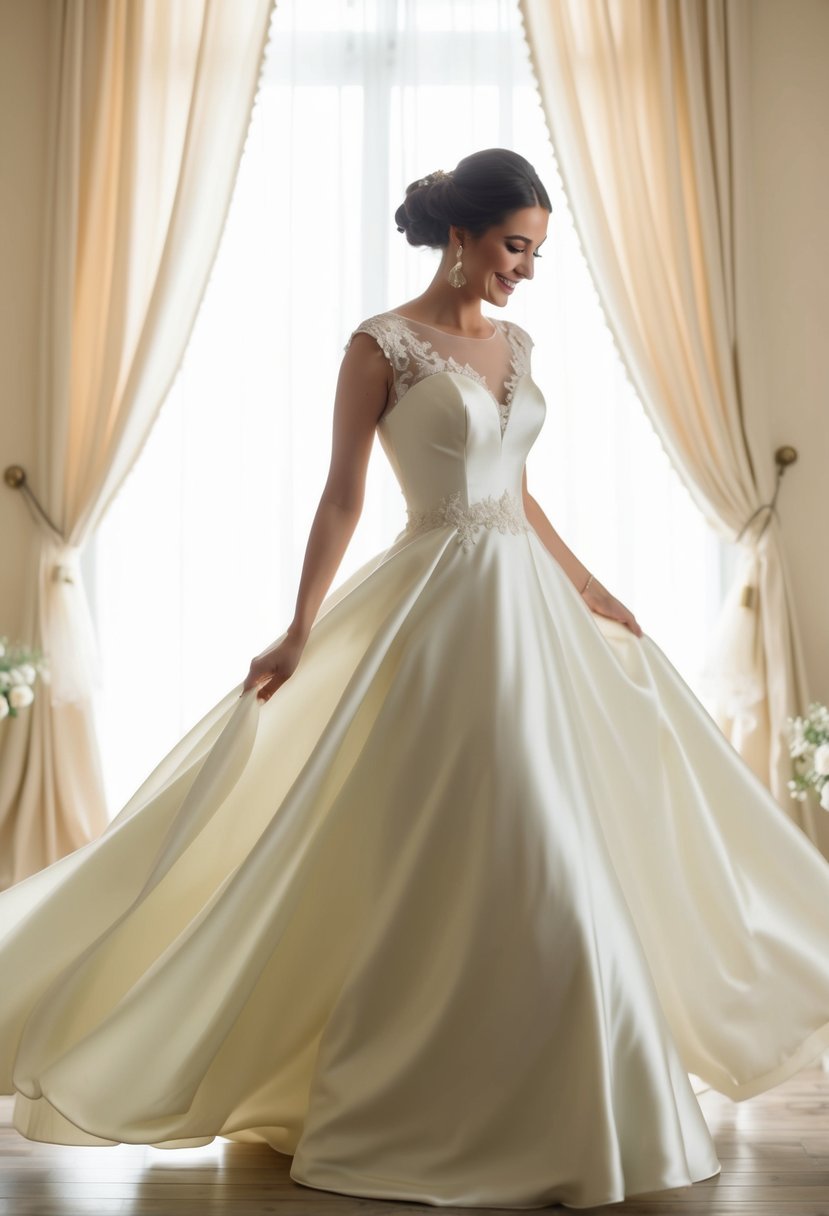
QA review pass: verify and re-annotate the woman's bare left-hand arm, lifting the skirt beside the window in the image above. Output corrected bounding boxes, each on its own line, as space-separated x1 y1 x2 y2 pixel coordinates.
242 333 391 700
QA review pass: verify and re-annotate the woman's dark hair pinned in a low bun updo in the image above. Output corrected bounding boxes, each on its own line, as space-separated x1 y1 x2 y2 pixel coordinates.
394 148 553 249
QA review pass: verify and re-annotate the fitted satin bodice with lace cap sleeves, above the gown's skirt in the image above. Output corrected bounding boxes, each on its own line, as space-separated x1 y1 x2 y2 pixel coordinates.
346 313 546 539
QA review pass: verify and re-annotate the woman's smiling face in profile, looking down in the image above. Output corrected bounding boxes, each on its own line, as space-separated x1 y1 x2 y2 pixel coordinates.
449 207 549 308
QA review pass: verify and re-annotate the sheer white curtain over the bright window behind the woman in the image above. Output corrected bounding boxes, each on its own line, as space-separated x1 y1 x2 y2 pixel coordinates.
89 0 729 812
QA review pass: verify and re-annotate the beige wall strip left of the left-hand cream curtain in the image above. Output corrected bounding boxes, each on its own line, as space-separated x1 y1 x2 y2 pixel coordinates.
0 0 52 642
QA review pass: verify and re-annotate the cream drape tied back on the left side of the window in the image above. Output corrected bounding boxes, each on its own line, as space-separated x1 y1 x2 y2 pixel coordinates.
0 0 273 886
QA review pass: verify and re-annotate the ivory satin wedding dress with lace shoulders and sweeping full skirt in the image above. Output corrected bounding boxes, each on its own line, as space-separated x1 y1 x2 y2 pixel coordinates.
0 313 829 1207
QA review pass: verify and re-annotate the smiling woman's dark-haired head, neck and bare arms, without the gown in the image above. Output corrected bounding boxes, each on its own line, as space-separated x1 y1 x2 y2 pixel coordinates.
239 150 642 700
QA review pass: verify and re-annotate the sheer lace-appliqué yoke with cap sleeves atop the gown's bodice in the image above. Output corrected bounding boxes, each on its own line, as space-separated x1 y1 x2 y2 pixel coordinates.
345 311 532 434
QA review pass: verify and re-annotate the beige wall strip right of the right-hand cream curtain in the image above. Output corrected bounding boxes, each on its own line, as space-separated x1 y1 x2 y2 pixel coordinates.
751 0 829 704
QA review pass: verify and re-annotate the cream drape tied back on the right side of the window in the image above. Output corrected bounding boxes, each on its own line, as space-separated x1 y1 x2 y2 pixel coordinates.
520 0 829 857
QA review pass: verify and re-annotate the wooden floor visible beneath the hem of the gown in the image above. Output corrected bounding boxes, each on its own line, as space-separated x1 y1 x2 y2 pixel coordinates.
0 1066 829 1216
